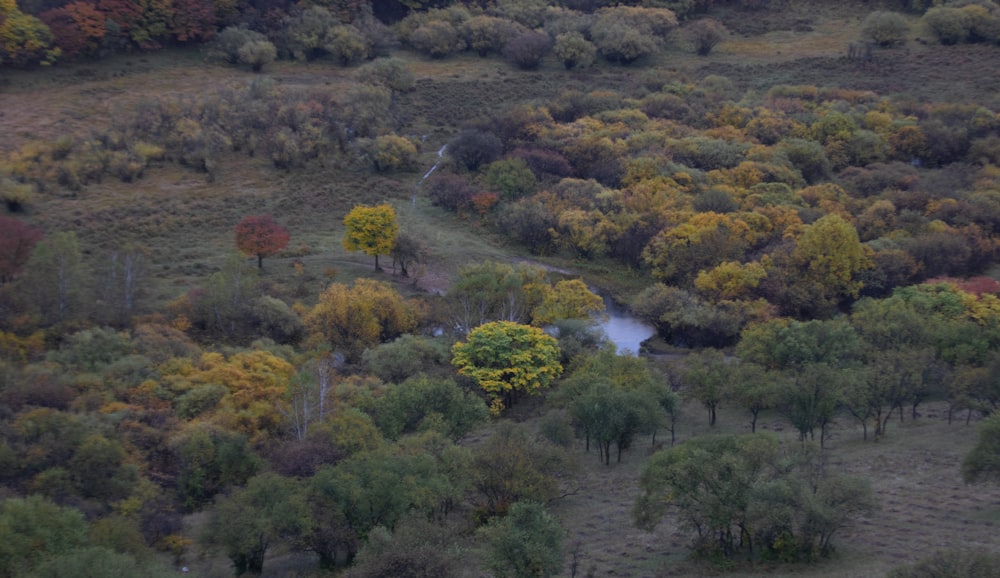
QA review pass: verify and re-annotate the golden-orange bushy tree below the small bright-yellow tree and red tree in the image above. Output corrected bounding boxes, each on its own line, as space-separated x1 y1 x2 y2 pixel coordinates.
305 279 422 362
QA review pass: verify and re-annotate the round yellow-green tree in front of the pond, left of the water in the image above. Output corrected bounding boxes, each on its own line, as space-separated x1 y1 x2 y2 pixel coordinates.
451 321 562 414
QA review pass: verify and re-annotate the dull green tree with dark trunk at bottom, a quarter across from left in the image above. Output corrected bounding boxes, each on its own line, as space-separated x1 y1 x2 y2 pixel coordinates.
203 473 309 576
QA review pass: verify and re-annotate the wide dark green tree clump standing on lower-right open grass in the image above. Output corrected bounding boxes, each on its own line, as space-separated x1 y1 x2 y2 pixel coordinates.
633 434 873 562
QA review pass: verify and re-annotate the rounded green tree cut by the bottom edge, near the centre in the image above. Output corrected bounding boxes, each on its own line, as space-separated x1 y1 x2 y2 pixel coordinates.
480 502 565 578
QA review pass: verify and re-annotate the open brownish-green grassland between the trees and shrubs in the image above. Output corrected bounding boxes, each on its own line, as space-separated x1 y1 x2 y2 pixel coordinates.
0 1 1000 577
